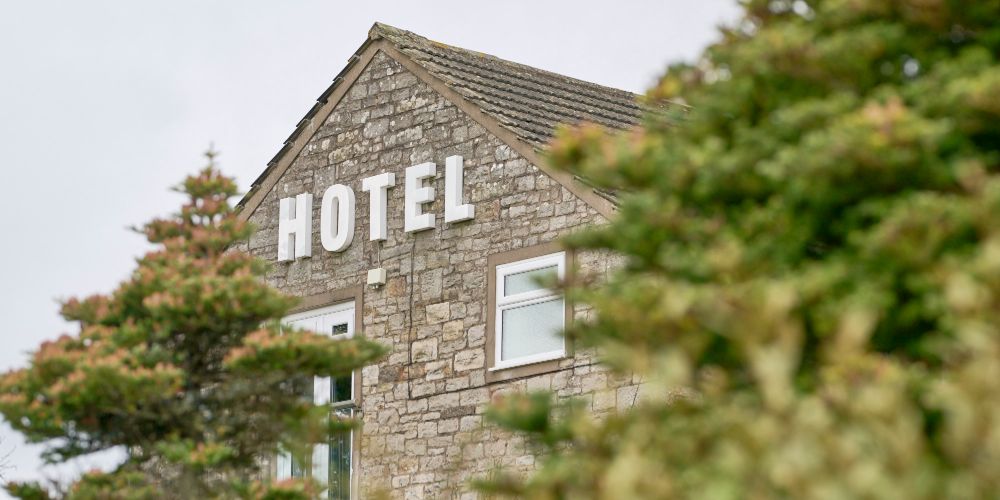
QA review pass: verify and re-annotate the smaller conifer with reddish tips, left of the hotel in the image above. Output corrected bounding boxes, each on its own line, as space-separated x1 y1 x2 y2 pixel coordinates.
0 158 383 499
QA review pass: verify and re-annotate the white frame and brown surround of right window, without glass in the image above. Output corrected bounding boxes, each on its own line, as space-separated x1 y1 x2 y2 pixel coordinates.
485 242 574 383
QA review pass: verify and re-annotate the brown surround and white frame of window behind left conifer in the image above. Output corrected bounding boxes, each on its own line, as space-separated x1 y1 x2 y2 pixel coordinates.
270 285 364 499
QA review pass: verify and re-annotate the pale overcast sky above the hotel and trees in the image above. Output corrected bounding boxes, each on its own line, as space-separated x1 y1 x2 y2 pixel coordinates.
0 0 736 492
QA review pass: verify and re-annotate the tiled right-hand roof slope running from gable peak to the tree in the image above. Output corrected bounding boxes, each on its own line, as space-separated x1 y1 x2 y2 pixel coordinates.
369 23 642 148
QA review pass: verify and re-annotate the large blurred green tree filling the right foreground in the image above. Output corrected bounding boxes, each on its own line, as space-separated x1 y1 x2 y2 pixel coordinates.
479 0 1000 499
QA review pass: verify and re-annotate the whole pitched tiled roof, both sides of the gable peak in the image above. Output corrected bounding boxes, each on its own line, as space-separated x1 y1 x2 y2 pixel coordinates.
237 23 644 216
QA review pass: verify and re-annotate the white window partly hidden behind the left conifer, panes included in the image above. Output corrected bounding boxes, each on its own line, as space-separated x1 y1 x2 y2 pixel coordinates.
276 300 357 500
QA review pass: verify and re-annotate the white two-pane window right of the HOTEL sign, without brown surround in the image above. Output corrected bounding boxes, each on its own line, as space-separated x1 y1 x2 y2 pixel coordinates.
490 252 566 370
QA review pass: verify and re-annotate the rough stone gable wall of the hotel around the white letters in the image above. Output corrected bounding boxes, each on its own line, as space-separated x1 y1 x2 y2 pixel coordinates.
238 53 636 498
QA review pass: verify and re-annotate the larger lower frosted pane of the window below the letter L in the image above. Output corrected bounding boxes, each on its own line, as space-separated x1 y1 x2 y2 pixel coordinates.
500 298 566 361
